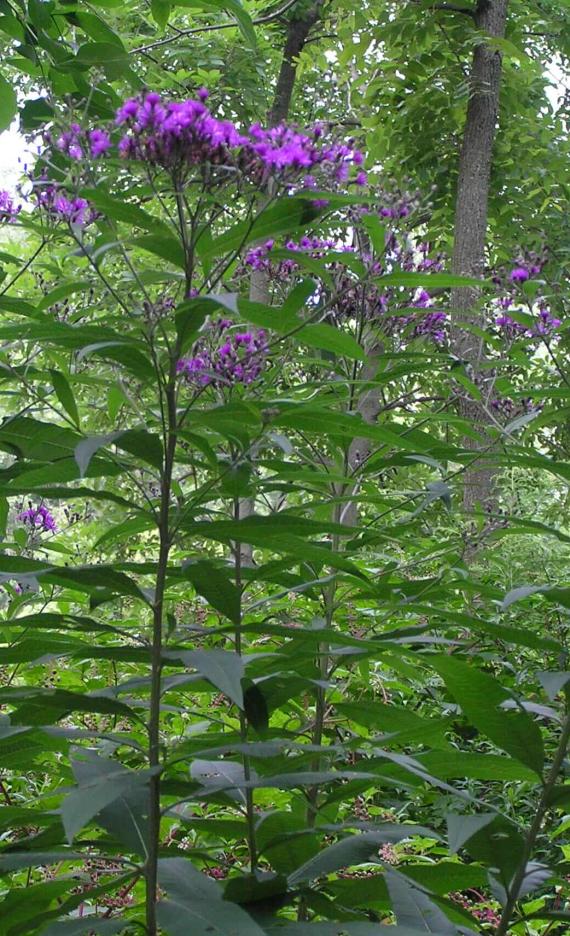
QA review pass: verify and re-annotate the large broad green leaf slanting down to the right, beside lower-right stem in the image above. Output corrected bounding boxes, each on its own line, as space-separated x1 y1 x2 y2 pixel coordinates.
430 656 544 777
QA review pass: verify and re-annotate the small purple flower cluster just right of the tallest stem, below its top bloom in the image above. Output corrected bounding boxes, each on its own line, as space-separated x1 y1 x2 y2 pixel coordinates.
176 319 268 387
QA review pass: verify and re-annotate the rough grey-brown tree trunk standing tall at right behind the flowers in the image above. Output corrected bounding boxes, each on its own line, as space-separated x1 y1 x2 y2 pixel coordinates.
451 0 508 510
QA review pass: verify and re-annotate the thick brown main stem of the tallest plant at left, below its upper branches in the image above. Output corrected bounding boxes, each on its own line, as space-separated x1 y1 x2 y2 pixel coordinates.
145 380 177 936
